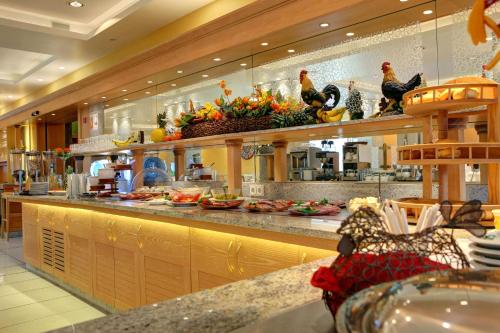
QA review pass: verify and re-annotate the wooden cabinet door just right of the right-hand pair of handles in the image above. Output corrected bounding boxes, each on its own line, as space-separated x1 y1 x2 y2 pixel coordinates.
235 236 299 279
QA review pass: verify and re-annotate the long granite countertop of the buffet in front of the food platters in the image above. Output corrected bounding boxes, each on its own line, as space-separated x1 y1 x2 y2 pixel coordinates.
3 194 348 240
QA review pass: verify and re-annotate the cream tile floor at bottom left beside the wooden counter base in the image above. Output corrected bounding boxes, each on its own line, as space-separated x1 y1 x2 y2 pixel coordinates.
0 238 104 333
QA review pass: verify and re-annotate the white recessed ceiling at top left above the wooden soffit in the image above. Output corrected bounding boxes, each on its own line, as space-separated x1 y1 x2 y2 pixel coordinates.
0 0 214 109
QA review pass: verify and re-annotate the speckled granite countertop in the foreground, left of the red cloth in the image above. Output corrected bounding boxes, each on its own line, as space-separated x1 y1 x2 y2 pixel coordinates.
53 257 334 333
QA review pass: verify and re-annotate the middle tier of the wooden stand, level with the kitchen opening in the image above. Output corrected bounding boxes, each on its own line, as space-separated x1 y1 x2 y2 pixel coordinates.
398 142 500 165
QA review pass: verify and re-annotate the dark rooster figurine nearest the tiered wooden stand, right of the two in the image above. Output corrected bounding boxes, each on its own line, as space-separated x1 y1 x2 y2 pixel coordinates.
378 61 422 116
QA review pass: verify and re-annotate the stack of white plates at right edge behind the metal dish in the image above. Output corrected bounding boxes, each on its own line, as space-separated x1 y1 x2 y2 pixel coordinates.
469 231 500 269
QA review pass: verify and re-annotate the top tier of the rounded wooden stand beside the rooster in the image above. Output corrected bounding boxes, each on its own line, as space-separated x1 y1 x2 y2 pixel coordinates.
403 83 498 117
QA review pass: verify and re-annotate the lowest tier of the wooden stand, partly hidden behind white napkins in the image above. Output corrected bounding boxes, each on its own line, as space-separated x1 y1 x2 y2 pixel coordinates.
391 198 500 227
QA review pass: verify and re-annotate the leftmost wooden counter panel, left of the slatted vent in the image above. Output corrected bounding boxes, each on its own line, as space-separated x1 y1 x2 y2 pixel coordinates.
22 204 40 268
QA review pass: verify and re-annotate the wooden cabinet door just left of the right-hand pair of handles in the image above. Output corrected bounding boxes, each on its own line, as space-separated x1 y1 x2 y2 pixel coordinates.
190 228 240 292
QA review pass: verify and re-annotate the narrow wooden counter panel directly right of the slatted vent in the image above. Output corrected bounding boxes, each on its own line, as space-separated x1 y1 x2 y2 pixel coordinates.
64 209 92 294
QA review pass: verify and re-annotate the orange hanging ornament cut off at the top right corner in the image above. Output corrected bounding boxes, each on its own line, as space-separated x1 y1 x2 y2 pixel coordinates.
467 0 500 70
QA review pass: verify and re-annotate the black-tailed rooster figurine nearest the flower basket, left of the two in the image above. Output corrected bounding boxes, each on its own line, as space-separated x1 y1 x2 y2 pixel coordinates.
300 70 340 113
